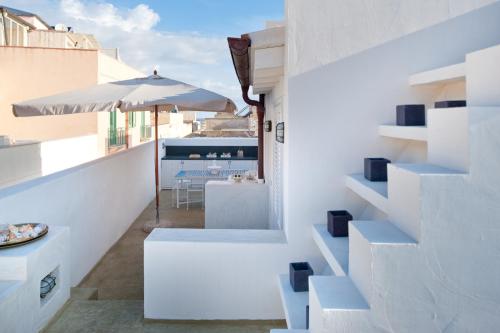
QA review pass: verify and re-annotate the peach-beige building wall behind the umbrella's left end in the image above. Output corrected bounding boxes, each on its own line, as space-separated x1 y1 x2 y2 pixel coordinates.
0 47 98 140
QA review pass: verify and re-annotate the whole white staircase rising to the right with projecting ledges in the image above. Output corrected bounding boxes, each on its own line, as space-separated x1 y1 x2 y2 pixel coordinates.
274 42 500 333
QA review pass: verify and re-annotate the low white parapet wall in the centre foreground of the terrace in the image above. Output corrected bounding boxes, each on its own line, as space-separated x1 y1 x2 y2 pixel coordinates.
144 229 288 319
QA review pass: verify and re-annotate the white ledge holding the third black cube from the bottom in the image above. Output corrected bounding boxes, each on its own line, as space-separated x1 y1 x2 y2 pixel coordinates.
346 173 389 213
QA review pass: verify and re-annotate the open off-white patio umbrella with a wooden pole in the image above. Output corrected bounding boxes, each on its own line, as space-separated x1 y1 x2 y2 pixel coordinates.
12 71 236 231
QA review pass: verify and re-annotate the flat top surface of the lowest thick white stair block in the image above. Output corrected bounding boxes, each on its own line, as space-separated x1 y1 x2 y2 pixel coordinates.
309 275 370 311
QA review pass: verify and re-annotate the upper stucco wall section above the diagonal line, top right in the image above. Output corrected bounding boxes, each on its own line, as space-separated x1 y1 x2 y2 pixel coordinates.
286 0 497 75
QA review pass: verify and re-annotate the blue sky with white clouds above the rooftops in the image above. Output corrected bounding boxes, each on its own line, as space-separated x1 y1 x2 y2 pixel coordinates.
0 0 284 108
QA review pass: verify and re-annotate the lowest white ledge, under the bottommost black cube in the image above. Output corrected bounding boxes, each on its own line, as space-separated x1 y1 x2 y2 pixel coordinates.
279 274 309 329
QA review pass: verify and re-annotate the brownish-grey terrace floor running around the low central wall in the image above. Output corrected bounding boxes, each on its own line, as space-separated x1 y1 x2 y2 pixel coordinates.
44 191 286 333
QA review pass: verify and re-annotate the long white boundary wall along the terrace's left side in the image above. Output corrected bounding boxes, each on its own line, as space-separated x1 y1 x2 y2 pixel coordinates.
0 143 154 286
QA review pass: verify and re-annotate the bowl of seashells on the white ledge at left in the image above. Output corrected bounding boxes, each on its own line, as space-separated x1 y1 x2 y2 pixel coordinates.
0 223 49 249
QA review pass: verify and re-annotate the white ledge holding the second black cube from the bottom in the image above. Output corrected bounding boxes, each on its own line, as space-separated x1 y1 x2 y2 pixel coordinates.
313 224 349 276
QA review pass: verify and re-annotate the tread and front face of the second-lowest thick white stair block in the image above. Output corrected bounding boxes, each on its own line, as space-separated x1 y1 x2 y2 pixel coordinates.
349 221 417 302
